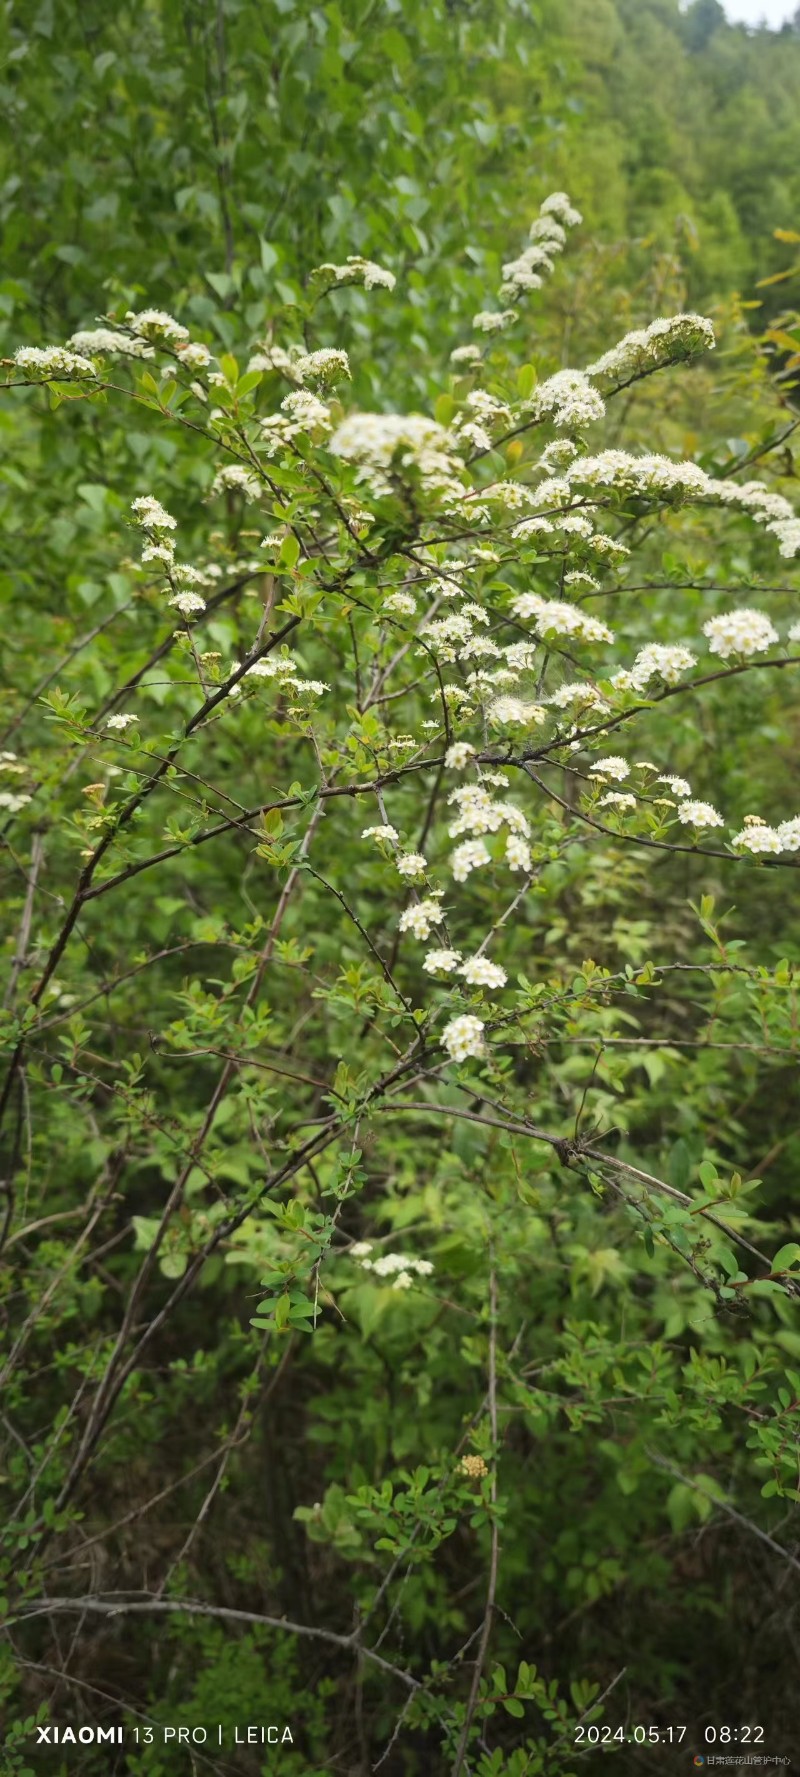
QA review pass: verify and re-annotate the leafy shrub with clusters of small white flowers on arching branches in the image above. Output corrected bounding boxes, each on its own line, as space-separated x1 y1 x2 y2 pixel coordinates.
0 204 800 1773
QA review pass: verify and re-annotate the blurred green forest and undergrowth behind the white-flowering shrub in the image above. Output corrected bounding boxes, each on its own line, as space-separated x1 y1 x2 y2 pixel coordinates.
0 0 800 1777
